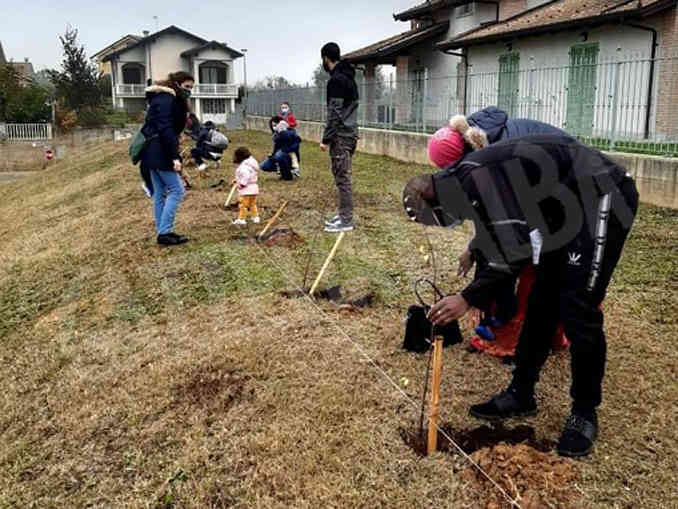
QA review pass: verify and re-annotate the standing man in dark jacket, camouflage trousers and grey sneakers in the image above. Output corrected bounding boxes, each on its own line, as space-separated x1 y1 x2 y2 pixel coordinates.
320 42 359 233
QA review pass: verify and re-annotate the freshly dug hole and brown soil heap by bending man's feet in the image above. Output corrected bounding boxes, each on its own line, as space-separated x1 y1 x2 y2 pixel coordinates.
400 425 580 509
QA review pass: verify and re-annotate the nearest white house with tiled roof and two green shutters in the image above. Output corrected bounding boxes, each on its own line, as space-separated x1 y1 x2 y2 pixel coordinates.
437 0 678 140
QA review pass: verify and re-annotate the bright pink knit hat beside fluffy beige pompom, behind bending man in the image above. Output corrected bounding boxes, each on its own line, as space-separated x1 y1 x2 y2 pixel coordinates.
428 115 488 169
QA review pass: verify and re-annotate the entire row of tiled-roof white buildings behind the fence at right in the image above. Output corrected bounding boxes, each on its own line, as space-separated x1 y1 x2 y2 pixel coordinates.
344 0 678 142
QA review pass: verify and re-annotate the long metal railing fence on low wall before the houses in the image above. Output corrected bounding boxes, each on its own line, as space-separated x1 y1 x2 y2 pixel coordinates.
248 52 678 156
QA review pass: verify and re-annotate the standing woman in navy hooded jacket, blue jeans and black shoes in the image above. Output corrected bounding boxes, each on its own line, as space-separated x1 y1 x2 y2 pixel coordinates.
141 71 195 246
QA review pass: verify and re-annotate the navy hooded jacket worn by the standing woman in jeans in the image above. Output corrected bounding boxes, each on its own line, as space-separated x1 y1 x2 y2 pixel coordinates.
141 85 188 171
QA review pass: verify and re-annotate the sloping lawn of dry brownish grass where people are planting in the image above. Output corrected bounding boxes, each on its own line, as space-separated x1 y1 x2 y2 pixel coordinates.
0 132 678 509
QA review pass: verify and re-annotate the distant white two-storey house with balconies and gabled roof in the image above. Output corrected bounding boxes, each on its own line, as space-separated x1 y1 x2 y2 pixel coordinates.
104 26 243 124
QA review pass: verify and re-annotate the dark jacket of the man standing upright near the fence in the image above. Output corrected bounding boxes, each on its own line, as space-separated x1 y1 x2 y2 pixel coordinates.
323 60 360 145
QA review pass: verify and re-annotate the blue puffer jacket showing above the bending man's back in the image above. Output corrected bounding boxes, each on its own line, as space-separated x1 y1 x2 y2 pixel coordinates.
467 106 567 145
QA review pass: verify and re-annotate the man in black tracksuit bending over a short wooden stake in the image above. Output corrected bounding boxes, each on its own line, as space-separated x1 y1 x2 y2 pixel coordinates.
403 135 638 457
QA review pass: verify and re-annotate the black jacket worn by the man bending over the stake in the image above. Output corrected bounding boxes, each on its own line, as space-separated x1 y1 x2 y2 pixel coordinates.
433 135 627 309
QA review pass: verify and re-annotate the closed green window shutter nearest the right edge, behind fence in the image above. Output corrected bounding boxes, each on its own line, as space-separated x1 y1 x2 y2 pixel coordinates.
567 43 600 136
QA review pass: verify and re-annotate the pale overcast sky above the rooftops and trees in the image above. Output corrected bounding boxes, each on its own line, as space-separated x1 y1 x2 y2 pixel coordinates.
0 0 419 83
